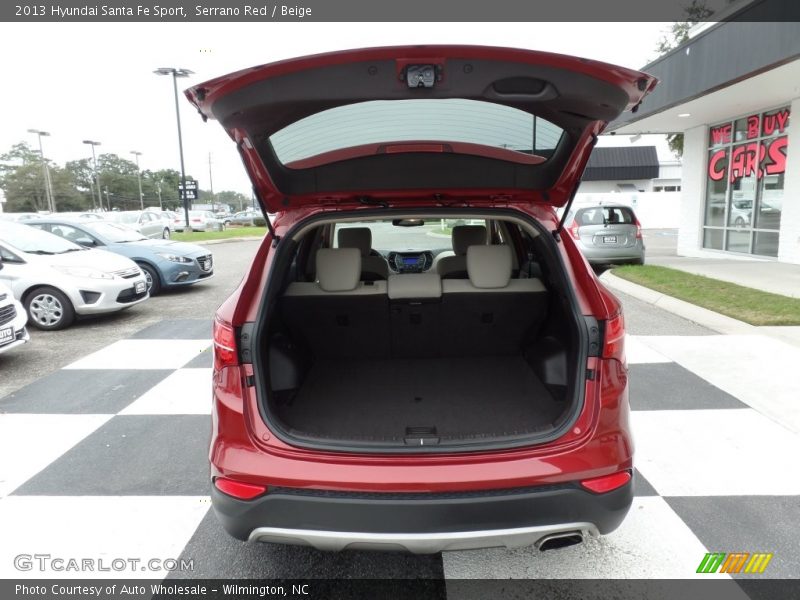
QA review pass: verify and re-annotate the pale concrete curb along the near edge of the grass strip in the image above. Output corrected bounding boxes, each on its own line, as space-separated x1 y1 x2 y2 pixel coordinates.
600 271 759 335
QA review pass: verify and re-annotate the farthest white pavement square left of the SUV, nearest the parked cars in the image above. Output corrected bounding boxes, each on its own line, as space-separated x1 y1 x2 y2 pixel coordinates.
64 340 211 369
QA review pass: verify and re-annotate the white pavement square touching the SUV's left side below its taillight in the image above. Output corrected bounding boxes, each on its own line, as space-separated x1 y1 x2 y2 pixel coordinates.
119 369 212 415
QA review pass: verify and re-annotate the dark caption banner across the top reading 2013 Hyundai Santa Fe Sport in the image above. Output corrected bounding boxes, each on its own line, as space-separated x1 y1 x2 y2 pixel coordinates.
0 0 800 22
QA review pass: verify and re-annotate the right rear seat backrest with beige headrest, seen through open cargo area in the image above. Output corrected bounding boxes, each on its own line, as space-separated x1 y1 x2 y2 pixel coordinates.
441 245 547 356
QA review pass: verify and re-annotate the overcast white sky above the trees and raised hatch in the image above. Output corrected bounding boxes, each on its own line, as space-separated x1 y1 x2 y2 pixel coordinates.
0 23 670 196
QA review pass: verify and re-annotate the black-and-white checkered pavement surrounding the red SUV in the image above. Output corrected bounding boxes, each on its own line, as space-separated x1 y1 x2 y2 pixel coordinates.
0 319 800 578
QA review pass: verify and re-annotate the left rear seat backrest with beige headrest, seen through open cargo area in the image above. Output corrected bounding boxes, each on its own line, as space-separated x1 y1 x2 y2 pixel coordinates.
281 248 389 358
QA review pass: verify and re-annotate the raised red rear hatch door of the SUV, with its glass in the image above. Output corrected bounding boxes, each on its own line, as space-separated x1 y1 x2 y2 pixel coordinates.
186 46 656 213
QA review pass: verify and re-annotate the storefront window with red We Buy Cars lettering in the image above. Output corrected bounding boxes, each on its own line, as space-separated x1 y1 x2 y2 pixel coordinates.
703 107 790 256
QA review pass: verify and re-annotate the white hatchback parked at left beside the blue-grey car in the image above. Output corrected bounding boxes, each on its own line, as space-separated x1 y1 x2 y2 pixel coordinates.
0 223 149 329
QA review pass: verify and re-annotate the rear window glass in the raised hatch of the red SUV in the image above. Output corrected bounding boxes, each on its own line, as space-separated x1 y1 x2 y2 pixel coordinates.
269 98 563 164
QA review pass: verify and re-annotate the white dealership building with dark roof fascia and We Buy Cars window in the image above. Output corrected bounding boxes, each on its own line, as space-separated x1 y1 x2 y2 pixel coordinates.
609 0 800 264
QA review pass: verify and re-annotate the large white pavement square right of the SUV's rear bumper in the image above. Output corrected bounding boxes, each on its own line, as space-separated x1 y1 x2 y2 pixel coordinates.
631 408 800 496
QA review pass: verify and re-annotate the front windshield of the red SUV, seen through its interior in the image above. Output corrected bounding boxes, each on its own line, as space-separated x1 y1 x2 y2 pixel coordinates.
333 219 486 254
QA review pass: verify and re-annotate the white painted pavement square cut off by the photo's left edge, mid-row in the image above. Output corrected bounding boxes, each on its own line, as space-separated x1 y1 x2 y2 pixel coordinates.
0 414 114 500
